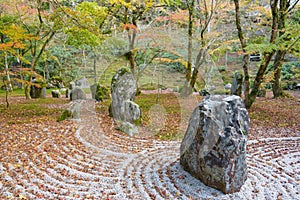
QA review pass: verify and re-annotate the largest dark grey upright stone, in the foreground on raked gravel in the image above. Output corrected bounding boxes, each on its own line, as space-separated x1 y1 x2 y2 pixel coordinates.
180 95 250 193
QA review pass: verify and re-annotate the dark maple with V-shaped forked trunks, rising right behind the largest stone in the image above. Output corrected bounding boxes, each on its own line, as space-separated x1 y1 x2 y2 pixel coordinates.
234 0 300 108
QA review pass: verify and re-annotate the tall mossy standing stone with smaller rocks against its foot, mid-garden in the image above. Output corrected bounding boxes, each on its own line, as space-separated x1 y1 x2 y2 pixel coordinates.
110 68 141 136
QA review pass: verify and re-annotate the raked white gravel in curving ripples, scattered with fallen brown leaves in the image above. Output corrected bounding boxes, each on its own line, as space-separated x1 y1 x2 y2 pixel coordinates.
0 101 300 199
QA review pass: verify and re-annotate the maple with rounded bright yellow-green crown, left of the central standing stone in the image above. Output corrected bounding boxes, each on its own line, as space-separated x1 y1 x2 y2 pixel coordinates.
53 2 109 82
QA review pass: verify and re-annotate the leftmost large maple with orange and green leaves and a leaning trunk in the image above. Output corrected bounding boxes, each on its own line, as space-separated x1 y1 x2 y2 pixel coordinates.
0 0 64 99
